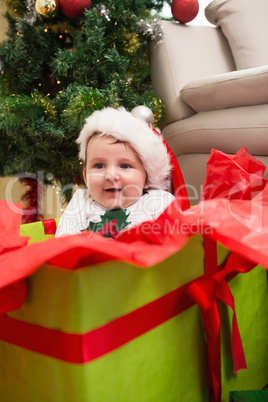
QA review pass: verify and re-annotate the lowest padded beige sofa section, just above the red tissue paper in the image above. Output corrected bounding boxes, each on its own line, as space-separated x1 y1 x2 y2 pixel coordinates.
162 104 268 156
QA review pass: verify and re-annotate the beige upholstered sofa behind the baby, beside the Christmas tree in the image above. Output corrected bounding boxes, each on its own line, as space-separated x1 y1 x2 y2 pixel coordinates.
150 0 268 204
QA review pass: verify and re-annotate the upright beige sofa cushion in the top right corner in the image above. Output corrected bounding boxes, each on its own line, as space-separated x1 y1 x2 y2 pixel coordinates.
205 0 268 70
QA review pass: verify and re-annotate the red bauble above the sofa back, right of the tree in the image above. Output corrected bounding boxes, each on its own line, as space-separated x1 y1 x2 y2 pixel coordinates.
171 0 199 24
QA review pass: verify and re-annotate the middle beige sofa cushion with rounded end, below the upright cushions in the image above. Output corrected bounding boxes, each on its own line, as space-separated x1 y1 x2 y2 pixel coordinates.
181 65 268 112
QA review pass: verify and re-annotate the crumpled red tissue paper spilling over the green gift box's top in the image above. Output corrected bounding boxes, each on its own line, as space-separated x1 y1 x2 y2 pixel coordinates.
0 150 268 287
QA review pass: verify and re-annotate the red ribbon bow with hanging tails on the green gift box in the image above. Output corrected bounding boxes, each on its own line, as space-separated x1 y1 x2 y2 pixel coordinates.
187 237 256 402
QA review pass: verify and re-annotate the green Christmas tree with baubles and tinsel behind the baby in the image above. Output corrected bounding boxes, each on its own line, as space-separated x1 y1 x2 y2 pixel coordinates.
0 0 169 220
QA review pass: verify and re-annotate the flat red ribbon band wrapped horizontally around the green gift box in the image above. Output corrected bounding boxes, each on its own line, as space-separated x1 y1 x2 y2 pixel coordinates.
0 283 194 364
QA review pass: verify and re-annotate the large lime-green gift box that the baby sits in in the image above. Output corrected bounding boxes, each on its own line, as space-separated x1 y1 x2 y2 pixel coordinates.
0 222 268 402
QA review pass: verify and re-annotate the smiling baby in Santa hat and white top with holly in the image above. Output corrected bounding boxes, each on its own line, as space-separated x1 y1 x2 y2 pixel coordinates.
56 108 174 238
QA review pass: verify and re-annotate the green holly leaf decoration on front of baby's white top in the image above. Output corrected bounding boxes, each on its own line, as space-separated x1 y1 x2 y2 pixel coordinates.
87 209 130 239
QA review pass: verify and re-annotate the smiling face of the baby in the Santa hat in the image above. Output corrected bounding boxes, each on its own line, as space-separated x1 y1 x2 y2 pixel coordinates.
84 136 147 209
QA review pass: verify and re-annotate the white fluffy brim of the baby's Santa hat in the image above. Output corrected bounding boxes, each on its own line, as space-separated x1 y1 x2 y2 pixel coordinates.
76 108 171 190
